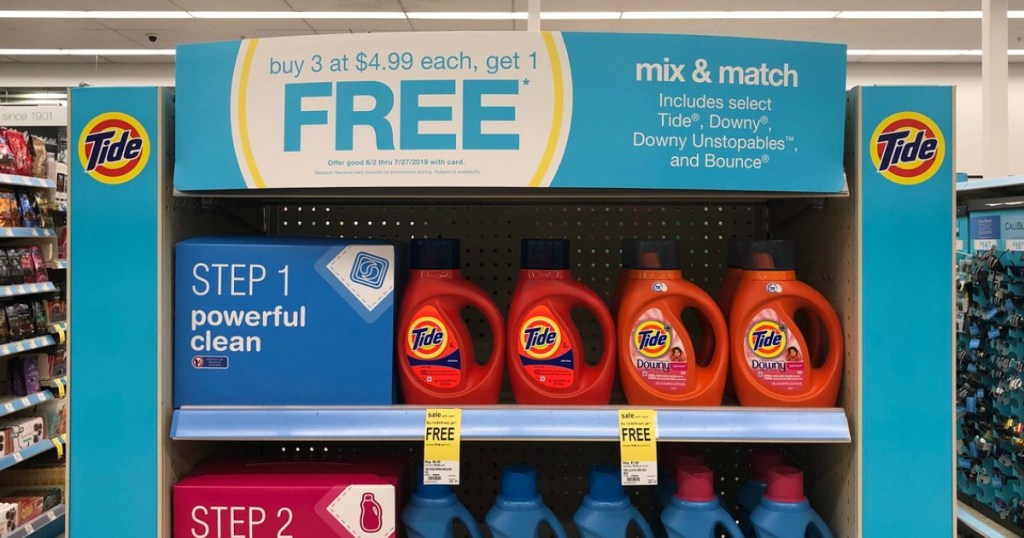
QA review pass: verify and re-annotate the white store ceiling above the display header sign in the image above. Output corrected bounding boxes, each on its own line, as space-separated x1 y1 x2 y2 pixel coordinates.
0 0 1024 63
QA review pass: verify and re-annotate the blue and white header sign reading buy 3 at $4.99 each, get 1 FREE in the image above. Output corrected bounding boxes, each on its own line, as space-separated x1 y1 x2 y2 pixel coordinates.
174 32 846 193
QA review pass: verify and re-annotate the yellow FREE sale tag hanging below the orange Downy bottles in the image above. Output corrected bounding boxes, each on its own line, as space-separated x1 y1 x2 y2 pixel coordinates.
618 409 657 486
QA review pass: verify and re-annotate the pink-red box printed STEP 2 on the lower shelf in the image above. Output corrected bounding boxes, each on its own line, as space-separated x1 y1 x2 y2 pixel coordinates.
173 462 402 538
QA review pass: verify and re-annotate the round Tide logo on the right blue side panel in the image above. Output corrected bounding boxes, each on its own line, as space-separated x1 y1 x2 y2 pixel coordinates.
868 111 946 185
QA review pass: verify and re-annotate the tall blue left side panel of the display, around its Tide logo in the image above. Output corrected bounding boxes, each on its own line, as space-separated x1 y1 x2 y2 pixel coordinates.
69 87 161 538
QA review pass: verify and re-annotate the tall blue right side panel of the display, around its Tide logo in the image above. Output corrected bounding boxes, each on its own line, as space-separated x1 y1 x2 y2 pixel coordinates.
860 87 955 536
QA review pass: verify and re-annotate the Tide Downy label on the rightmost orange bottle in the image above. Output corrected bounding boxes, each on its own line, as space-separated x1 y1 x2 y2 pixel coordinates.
743 308 807 391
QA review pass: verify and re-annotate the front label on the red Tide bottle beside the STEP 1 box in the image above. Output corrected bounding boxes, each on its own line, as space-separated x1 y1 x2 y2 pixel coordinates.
406 304 462 388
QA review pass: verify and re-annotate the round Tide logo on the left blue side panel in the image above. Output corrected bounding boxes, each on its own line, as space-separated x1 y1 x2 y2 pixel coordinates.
78 112 150 184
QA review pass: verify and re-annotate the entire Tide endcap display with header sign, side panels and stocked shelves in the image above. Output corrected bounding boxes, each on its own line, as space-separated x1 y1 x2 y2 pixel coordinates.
70 27 953 538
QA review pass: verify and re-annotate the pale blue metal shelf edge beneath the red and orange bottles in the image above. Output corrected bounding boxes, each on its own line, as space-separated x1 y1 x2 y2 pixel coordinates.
171 406 850 443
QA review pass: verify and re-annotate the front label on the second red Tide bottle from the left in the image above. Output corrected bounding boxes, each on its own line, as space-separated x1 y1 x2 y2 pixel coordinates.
516 304 575 388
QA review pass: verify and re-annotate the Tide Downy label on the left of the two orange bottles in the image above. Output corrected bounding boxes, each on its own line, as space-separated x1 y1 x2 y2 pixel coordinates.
630 308 687 394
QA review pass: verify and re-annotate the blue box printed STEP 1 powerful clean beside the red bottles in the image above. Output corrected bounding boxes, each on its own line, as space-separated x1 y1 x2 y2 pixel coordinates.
174 238 395 407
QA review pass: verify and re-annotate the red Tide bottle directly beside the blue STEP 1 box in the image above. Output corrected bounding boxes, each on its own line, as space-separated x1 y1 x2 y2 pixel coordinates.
397 239 505 405
